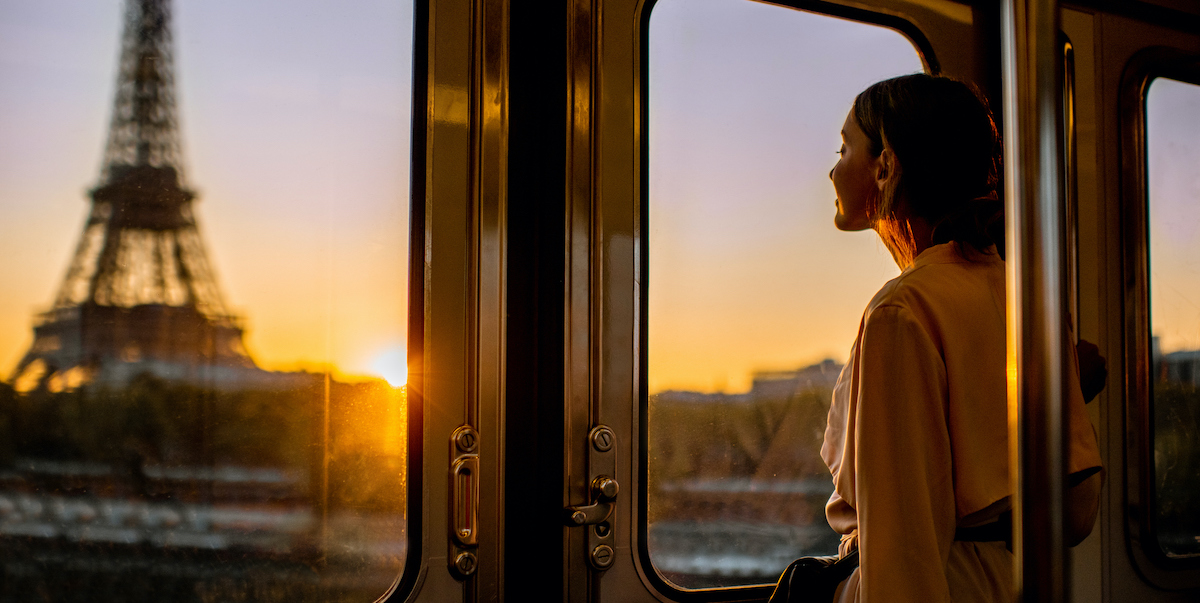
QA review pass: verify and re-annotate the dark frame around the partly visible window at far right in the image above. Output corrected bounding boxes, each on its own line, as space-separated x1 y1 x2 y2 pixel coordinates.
1117 47 1200 581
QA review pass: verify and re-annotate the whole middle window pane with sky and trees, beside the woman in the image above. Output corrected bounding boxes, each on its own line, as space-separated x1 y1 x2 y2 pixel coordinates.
644 0 923 589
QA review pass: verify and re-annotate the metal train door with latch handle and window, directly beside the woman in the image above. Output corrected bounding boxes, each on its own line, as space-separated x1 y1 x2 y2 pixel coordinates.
563 0 1002 602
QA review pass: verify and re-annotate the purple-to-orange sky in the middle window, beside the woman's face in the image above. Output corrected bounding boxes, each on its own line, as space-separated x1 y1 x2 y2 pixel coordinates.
647 0 922 392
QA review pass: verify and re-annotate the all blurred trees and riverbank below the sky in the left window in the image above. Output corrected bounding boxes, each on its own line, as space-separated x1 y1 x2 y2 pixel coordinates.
0 374 407 603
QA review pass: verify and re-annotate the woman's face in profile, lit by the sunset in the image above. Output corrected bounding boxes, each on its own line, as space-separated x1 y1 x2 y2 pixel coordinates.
829 109 880 231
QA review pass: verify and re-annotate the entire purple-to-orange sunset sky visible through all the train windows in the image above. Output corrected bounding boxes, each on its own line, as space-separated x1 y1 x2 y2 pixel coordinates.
0 0 1200 392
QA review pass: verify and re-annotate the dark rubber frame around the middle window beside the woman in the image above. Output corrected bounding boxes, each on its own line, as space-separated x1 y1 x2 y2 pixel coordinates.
634 0 942 603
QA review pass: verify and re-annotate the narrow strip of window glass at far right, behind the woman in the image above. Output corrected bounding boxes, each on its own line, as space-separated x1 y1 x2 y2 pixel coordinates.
1146 79 1200 556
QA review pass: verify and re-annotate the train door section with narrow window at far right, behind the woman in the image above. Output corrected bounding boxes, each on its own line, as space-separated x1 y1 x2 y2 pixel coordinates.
1062 2 1200 601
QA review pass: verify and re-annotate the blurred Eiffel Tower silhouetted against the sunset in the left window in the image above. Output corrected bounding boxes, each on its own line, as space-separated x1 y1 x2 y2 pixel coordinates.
12 0 255 390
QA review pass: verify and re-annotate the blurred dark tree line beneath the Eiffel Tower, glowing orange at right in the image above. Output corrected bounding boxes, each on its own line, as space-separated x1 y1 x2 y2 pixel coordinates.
0 374 407 512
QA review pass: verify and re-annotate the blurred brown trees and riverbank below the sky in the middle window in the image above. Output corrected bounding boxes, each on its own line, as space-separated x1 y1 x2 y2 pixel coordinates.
647 377 839 589
